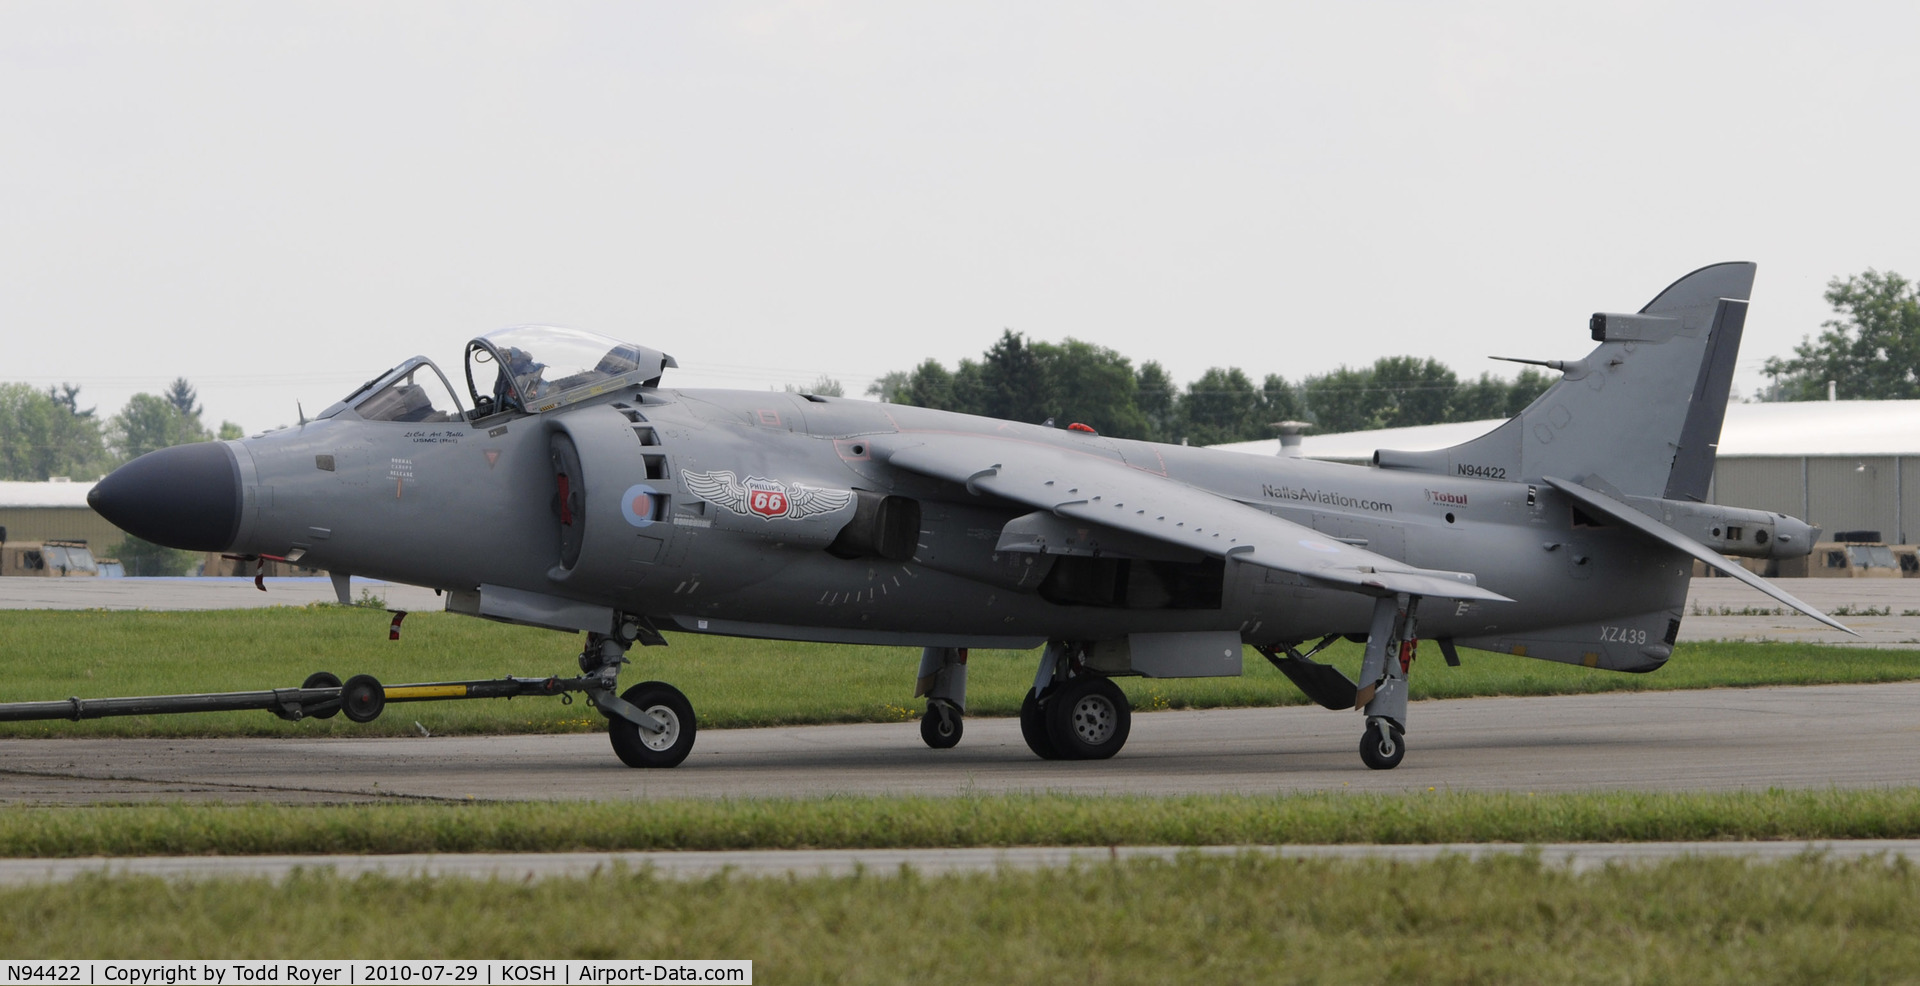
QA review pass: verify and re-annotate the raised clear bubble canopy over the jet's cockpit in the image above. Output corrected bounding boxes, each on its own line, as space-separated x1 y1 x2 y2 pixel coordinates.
467 326 680 418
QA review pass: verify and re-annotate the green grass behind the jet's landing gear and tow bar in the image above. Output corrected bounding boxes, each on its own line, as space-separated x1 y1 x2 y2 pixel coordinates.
0 606 1920 737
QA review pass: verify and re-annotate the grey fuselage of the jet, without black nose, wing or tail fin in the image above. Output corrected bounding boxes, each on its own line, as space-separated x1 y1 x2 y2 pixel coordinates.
228 387 1690 669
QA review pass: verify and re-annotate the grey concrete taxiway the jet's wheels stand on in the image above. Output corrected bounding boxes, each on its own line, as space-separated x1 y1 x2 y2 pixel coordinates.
0 683 1920 804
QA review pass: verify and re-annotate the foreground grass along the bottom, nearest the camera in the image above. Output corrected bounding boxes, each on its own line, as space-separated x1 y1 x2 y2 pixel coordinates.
0 856 1920 984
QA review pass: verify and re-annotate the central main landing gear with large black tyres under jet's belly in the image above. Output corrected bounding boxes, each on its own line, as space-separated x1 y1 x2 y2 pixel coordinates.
1020 641 1133 760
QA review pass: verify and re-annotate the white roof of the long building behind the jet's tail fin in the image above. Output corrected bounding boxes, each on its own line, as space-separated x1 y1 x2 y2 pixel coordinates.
1210 401 1920 462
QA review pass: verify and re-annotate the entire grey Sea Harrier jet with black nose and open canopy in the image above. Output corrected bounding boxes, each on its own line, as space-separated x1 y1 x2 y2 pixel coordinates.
88 263 1845 769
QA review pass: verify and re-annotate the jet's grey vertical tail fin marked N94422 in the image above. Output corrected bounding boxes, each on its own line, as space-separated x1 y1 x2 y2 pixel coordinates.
1373 263 1755 501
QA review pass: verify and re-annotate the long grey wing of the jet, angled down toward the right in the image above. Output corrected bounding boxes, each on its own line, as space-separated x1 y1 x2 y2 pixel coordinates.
874 435 1511 602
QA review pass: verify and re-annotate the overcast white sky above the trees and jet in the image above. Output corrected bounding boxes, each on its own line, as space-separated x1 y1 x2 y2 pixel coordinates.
0 0 1920 430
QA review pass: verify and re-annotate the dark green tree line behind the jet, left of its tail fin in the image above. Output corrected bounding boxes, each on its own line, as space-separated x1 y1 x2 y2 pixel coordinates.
868 330 1551 445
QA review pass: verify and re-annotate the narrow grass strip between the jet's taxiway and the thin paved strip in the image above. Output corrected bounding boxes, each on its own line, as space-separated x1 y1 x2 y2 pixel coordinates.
0 788 1920 857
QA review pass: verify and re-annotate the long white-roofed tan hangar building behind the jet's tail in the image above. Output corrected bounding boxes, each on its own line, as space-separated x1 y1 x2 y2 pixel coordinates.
1213 401 1920 545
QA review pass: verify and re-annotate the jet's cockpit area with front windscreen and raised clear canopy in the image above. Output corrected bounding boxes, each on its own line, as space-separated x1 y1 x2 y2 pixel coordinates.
319 326 678 424
